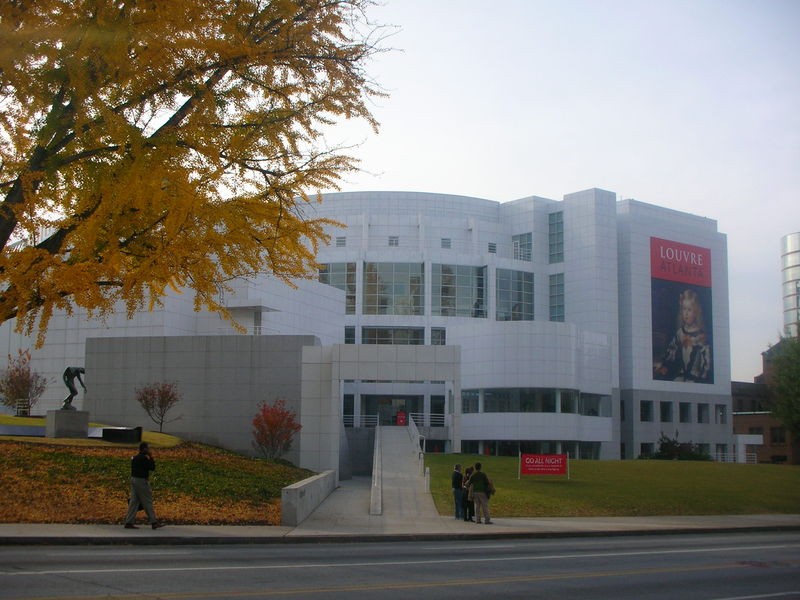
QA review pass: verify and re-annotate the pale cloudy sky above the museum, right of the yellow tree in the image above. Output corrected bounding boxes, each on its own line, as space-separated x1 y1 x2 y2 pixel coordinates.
320 0 800 381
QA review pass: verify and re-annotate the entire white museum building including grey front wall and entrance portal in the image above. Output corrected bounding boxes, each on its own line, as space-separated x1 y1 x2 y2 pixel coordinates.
0 189 732 469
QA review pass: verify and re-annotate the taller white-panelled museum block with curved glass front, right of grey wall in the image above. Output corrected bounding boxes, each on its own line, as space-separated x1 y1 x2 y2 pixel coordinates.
310 189 731 458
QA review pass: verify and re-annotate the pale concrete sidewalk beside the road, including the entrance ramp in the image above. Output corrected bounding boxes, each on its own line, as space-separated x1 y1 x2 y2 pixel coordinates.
0 428 800 545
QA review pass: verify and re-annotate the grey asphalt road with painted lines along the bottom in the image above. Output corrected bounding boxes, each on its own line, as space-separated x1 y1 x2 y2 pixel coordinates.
0 533 800 600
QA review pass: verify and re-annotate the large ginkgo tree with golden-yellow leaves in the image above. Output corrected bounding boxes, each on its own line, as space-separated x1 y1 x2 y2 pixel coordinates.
0 0 381 344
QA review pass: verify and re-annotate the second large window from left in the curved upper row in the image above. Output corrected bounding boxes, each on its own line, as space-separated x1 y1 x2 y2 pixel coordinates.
362 263 425 315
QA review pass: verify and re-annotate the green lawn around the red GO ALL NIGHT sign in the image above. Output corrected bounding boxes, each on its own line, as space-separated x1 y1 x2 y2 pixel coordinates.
425 454 800 517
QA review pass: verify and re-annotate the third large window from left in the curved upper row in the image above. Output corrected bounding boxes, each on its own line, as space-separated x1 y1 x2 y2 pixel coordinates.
431 264 486 319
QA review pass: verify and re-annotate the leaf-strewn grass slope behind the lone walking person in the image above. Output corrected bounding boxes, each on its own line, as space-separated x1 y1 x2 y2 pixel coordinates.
0 435 311 525
